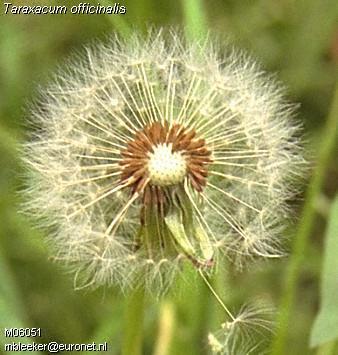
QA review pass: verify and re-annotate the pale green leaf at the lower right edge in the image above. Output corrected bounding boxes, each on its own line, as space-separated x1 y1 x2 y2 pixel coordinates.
310 195 338 347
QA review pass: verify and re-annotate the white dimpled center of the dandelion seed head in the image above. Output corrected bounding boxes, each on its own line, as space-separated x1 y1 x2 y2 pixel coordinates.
148 143 187 186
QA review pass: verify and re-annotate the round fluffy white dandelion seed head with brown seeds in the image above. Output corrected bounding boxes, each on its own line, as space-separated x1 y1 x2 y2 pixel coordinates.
24 32 303 292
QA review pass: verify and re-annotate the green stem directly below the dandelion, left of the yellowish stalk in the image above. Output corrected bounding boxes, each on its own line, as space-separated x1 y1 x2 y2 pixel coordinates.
122 289 144 355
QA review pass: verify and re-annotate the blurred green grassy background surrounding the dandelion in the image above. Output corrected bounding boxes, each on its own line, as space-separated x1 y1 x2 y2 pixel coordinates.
0 0 338 355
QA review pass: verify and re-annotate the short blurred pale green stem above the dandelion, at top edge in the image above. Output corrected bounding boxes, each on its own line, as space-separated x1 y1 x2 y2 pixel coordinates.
181 0 207 40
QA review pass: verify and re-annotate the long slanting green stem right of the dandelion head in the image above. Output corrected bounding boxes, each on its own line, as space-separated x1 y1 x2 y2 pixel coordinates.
271 85 338 355
